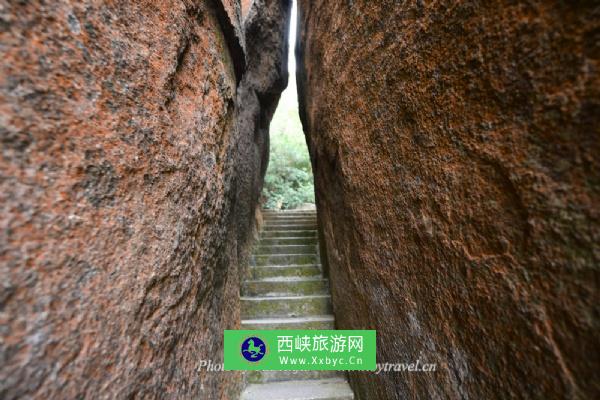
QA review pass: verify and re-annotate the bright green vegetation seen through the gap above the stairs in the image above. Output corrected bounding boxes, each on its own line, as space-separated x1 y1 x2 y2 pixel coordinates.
263 79 315 209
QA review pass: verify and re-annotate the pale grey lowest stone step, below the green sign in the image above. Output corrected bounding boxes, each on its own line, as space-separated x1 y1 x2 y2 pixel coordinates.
241 378 354 400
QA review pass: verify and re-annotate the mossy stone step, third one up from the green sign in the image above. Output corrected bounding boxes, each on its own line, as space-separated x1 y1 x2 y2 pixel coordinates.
242 277 329 297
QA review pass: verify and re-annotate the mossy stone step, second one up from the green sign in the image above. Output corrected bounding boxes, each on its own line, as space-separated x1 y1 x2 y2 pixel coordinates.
241 295 333 319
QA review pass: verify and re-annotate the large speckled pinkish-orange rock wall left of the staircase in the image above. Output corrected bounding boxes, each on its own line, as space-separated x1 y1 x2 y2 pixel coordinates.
0 0 287 399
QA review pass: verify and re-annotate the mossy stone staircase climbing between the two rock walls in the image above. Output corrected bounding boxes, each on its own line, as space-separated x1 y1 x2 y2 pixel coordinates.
241 211 354 400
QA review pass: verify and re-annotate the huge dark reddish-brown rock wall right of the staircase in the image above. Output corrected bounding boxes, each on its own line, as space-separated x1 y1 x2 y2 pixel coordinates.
298 0 600 400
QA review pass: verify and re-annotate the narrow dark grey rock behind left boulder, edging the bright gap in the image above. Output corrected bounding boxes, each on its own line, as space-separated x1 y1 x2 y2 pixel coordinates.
236 0 291 282
